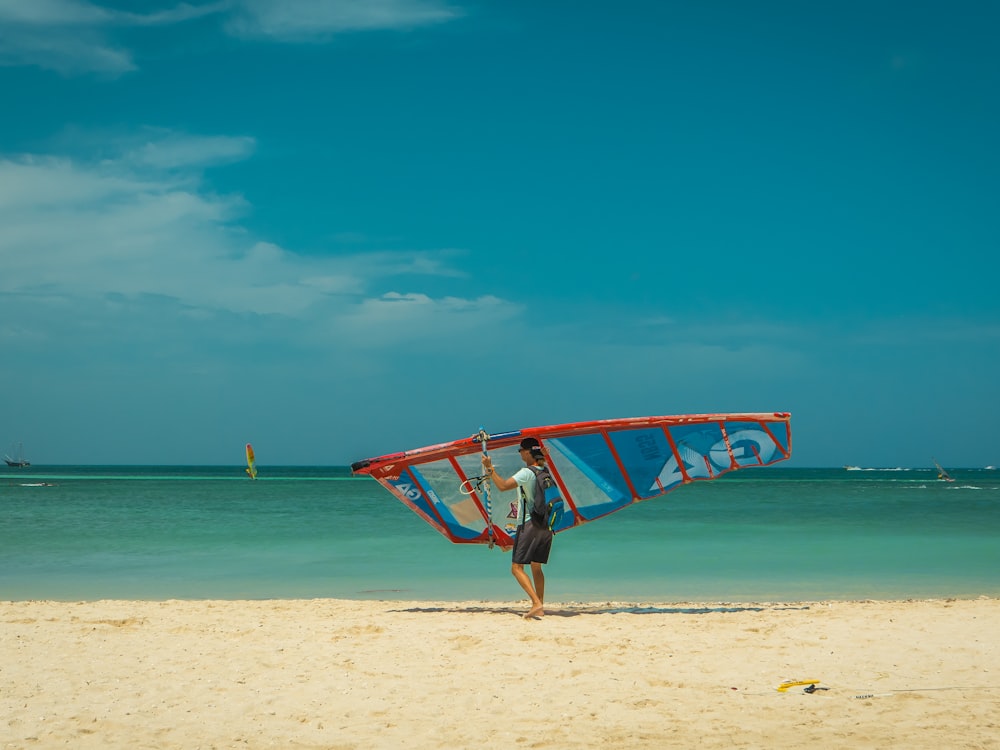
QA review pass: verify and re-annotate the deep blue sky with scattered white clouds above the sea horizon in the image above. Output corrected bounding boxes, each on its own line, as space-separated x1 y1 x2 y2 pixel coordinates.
0 0 1000 466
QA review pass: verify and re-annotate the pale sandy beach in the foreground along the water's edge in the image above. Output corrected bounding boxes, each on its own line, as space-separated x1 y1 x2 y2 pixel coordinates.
0 598 1000 748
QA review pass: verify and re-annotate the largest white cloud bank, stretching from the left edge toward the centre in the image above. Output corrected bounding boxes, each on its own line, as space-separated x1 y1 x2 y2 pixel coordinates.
0 133 505 337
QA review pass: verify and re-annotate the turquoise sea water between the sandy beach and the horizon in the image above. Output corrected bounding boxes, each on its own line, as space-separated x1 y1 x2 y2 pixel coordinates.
0 466 1000 602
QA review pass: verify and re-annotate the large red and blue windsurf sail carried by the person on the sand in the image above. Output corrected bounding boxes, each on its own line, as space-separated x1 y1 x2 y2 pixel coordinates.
351 412 792 547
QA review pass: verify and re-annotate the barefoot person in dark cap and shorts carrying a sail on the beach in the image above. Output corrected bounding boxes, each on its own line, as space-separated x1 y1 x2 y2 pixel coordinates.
483 438 552 619
